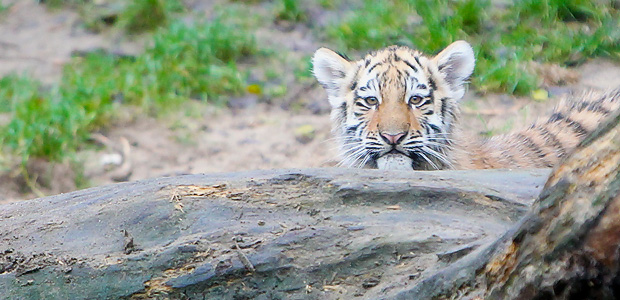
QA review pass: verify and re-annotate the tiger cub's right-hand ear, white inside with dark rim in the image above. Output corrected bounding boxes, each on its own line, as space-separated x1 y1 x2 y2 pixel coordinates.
433 41 476 98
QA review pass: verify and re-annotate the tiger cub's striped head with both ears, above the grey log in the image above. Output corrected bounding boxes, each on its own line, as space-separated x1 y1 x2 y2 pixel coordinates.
312 41 475 170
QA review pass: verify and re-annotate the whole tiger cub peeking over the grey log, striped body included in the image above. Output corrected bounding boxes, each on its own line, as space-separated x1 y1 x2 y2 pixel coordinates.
312 41 620 170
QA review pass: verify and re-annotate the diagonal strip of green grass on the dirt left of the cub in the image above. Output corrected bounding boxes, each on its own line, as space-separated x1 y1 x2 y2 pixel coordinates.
0 19 257 169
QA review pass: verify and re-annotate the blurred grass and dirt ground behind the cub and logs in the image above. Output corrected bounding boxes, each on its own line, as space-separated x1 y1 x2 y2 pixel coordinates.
0 0 620 203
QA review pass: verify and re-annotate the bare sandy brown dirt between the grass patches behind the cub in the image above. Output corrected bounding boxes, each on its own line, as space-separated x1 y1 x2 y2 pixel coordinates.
0 1 620 203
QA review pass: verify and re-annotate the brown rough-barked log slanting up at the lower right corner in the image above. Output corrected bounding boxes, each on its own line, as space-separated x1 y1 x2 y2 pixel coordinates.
410 114 620 300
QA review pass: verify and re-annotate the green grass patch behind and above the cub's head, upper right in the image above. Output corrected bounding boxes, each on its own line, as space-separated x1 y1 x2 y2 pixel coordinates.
326 0 620 94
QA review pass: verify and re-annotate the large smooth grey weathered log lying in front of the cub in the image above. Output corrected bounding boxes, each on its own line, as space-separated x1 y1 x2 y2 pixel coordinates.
0 169 549 299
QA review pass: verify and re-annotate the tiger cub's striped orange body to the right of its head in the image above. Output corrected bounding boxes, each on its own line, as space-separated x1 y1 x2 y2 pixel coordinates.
455 89 620 169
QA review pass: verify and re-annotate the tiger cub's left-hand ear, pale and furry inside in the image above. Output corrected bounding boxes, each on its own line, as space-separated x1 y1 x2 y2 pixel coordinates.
312 48 353 94
